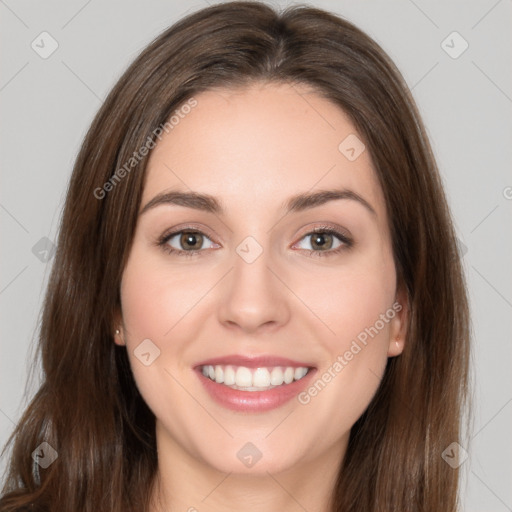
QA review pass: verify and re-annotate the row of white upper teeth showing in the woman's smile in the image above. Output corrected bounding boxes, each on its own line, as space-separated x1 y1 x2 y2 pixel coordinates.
202 365 309 391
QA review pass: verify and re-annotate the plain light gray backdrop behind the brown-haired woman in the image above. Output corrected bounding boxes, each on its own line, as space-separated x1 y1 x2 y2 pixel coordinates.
0 0 512 512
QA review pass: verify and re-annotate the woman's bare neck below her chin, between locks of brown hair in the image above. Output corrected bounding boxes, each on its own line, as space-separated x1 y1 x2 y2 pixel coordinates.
150 424 348 512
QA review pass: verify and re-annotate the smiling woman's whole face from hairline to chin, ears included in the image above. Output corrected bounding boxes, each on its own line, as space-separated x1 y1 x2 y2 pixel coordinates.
116 84 406 474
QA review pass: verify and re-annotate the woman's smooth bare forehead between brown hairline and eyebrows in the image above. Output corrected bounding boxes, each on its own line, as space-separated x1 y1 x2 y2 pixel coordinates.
142 83 385 220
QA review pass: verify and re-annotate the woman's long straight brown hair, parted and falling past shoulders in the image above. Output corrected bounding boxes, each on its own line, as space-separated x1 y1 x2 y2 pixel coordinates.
0 2 470 512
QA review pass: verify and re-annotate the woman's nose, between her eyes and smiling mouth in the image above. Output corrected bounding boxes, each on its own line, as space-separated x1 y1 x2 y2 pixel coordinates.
218 242 293 334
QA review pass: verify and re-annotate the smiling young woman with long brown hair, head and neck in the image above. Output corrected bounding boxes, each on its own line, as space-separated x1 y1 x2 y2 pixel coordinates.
0 2 469 512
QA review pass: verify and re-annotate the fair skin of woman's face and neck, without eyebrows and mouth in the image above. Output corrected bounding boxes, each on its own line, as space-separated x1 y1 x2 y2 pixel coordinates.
115 83 407 512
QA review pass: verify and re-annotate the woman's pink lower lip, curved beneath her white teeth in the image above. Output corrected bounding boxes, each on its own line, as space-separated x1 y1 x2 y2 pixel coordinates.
196 368 316 412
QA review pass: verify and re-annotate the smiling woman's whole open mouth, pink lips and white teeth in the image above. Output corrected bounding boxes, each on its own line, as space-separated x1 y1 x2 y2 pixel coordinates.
194 356 316 412
